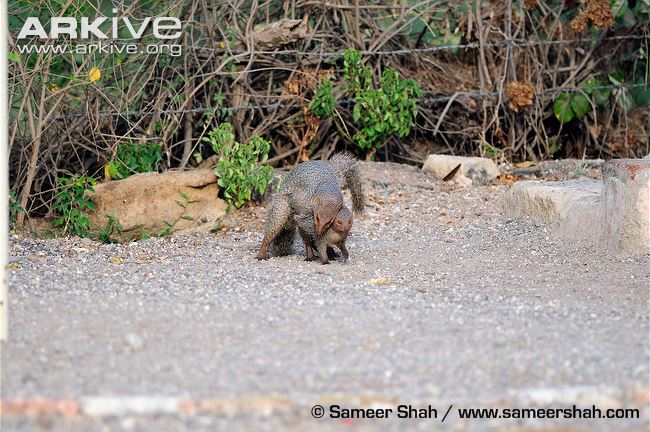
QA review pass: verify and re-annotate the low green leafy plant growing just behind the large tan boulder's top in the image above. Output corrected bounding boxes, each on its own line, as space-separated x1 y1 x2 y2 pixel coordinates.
105 142 162 180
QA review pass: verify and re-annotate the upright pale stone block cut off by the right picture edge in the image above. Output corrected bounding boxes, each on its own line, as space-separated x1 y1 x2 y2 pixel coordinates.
602 158 650 253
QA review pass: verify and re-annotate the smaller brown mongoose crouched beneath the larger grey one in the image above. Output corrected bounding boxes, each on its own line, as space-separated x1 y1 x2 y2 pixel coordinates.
295 206 352 264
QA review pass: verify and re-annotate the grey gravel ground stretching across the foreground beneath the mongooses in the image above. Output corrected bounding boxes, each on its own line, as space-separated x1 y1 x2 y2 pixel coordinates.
2 163 649 431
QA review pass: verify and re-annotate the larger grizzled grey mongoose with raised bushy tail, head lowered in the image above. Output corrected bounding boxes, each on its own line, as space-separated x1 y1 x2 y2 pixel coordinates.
257 153 365 259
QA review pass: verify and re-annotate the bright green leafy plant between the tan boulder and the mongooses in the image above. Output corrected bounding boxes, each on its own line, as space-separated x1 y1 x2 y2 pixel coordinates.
203 123 273 211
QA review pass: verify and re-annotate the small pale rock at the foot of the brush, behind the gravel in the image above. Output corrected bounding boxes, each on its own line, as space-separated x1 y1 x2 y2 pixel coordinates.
422 154 501 183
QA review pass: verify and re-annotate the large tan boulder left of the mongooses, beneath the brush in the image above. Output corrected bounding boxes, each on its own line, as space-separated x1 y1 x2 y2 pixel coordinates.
88 170 226 239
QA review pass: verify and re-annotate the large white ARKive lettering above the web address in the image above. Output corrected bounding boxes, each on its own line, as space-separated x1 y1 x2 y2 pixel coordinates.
17 9 182 40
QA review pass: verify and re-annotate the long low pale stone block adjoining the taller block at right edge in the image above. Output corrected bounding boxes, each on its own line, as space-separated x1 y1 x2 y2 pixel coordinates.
503 180 602 241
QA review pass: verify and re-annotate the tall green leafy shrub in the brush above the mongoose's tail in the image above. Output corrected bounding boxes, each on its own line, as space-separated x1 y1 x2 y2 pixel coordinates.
343 49 422 150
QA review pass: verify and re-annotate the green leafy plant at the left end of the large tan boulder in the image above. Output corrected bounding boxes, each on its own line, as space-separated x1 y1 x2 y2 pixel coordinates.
52 175 97 237
